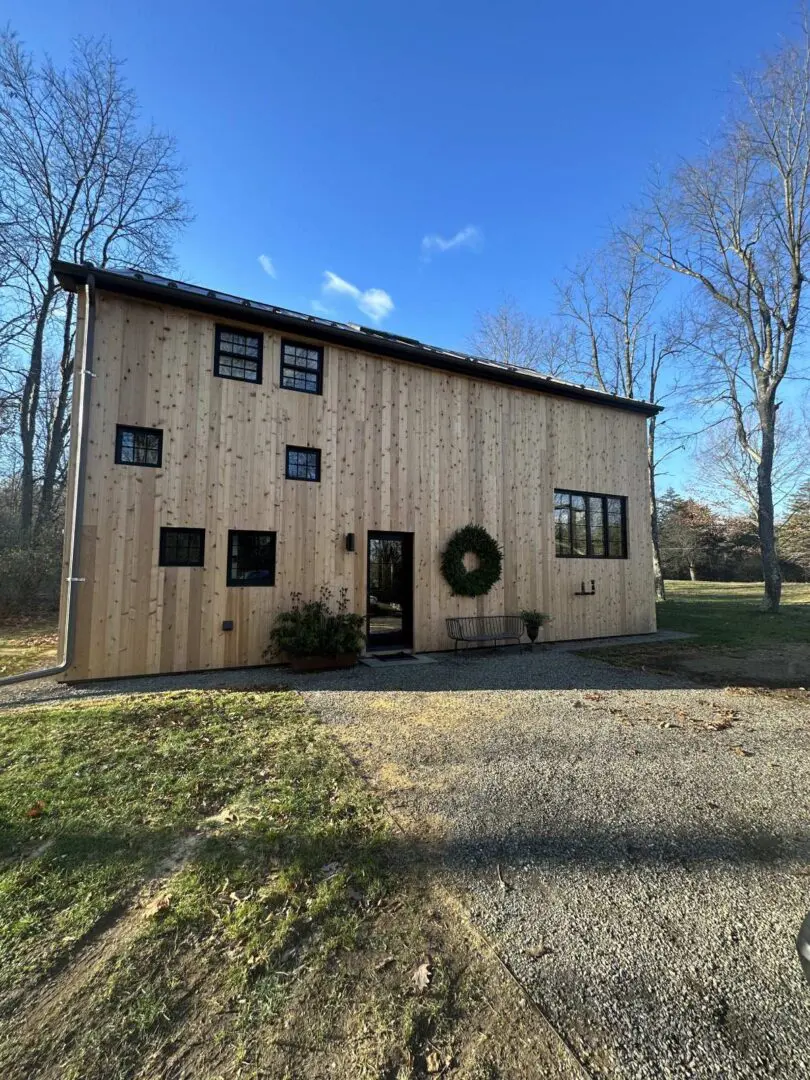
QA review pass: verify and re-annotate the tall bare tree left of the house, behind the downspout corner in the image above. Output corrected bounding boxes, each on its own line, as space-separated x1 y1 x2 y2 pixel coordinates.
0 31 188 540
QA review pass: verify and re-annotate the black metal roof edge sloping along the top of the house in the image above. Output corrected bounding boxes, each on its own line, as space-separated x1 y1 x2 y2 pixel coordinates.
53 261 661 416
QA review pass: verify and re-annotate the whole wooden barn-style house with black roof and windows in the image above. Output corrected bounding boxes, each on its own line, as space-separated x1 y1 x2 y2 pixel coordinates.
55 264 656 679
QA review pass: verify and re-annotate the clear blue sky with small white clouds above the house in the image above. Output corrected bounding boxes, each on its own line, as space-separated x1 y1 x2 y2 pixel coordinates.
4 0 797 488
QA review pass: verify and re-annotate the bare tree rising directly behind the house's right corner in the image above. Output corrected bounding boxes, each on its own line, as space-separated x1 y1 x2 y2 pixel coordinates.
557 229 683 599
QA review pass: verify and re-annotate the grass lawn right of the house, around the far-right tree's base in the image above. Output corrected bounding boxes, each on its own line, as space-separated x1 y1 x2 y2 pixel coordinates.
590 581 810 688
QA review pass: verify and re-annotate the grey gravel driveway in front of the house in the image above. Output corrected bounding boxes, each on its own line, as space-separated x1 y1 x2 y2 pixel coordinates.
306 651 810 1080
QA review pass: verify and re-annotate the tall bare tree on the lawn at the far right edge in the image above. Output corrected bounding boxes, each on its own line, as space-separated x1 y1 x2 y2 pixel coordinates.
644 23 810 611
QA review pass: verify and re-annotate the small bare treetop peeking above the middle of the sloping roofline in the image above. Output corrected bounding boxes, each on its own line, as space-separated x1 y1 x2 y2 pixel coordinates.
469 296 572 378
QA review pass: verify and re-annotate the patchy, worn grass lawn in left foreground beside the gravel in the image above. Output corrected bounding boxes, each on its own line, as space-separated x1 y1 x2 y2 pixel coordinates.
0 691 535 1080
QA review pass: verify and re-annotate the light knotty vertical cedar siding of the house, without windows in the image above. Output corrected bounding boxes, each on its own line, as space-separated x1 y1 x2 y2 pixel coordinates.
67 292 656 679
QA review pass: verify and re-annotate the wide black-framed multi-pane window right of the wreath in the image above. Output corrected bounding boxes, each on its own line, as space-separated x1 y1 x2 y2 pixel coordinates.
554 491 627 558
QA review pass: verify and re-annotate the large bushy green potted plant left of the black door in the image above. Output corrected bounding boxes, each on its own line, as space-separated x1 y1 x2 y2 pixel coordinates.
265 585 364 672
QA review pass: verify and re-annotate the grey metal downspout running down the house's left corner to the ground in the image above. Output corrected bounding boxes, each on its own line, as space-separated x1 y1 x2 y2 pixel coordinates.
0 273 96 687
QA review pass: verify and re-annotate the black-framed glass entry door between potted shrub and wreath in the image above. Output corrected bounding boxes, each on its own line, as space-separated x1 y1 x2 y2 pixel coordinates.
366 532 414 649
